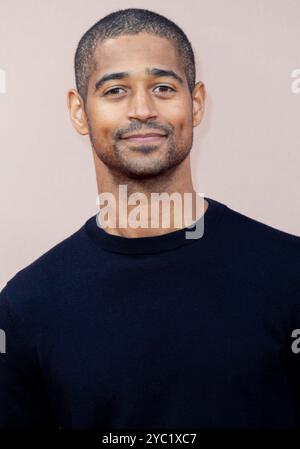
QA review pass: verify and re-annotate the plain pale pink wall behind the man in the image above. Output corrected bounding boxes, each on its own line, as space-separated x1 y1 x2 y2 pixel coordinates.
0 0 300 288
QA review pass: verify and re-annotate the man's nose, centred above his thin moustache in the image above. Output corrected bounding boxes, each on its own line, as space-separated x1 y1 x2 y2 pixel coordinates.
128 89 157 120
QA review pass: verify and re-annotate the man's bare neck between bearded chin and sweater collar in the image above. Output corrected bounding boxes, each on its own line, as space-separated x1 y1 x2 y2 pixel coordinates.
95 156 208 238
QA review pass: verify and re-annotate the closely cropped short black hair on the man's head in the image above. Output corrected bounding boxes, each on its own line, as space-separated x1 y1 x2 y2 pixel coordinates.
74 8 195 103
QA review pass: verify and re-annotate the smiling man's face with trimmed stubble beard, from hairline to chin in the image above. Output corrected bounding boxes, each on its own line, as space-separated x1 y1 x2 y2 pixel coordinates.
85 33 202 178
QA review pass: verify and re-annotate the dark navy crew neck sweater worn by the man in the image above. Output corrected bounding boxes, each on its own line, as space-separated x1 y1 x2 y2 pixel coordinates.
0 198 300 429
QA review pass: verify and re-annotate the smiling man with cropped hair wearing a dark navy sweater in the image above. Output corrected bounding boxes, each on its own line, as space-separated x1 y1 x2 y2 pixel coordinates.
0 9 300 429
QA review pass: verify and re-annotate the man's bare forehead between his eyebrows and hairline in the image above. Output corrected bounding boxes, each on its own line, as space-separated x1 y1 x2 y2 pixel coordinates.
94 33 184 76
